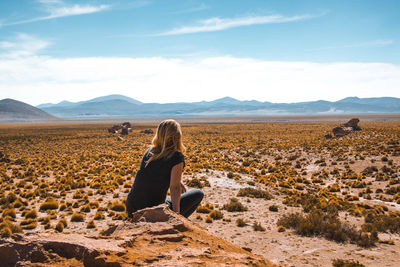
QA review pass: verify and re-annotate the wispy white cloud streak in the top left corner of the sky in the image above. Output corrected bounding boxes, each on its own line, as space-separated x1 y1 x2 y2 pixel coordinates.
2 0 110 26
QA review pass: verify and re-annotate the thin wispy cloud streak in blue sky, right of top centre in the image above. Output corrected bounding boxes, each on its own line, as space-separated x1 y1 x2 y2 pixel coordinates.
157 14 323 36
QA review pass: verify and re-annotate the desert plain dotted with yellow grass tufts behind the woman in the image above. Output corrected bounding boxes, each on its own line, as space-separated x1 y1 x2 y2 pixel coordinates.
0 115 400 266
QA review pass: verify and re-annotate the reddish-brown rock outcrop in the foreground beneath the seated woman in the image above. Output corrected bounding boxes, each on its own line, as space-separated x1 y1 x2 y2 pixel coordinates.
0 204 273 267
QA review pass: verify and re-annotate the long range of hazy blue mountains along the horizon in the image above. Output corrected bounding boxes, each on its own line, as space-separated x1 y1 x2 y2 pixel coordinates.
38 95 400 119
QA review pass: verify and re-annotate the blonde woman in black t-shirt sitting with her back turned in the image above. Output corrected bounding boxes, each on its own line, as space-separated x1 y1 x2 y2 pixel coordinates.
126 120 204 217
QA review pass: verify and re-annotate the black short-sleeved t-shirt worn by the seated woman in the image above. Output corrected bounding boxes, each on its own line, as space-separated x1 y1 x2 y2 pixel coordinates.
128 148 185 213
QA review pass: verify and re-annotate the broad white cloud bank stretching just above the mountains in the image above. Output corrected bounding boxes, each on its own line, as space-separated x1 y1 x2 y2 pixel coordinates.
0 52 400 104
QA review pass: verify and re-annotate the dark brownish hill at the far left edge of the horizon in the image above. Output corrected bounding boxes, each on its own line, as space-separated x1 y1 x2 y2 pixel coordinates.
0 98 57 122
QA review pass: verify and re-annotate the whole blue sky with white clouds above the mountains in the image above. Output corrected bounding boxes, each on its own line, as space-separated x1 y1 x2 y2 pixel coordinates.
0 0 400 105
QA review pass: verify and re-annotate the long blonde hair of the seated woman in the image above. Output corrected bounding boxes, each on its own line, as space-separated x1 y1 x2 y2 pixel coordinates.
146 119 186 166
